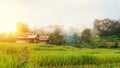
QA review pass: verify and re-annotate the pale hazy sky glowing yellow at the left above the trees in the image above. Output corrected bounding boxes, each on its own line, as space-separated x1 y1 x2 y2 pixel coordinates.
0 0 120 32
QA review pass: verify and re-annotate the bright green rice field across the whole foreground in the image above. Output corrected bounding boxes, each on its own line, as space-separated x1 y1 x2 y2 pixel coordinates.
0 42 120 68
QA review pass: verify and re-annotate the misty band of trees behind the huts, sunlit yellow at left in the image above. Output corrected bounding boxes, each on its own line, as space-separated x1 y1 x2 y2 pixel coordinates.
0 19 120 48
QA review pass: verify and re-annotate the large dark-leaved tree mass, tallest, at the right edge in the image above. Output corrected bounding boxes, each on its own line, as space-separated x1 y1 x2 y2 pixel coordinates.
94 19 120 36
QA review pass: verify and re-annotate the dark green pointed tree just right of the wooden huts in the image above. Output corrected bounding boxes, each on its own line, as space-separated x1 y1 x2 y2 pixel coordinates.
49 28 65 45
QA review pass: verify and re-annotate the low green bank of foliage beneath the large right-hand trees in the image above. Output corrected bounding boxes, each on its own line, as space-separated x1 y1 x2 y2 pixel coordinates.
92 35 120 48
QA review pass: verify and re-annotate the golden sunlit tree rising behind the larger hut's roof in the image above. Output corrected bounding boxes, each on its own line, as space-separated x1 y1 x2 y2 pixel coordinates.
16 22 30 33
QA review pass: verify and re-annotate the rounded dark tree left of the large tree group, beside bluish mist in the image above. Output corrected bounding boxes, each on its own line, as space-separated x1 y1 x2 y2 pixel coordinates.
81 29 92 42
